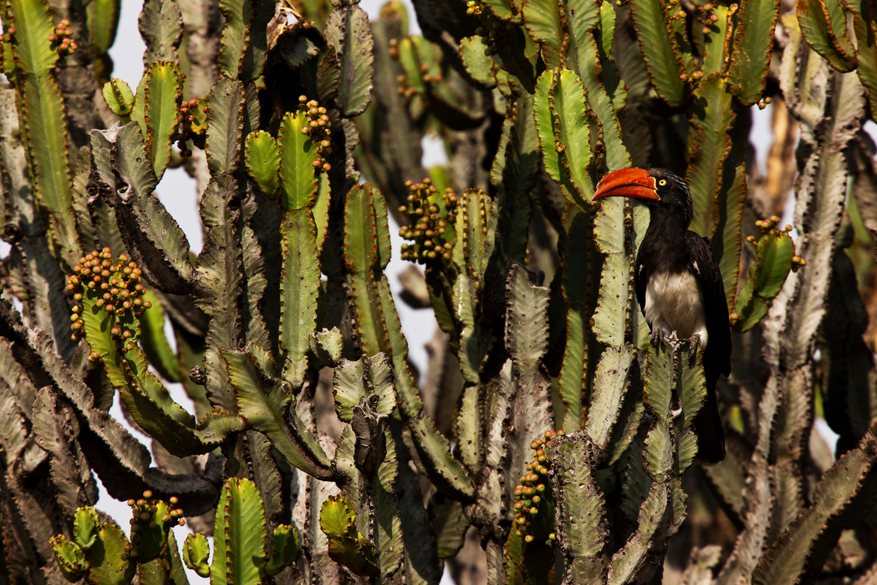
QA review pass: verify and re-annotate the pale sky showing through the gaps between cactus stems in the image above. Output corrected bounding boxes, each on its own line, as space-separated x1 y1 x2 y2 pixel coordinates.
0 0 856 585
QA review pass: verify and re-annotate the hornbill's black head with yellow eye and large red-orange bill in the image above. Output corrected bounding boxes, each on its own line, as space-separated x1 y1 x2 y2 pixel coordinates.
594 168 692 228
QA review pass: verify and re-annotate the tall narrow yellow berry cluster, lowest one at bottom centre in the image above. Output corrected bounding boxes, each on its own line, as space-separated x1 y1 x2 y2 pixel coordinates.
513 429 563 546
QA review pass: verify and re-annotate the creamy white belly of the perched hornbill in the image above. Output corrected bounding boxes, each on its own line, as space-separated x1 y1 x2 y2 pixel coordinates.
645 272 707 347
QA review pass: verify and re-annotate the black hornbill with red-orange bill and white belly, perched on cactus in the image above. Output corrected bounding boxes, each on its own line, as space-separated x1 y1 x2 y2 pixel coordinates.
594 168 731 463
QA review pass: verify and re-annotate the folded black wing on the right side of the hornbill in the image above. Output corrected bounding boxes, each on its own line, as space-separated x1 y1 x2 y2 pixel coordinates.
684 231 731 376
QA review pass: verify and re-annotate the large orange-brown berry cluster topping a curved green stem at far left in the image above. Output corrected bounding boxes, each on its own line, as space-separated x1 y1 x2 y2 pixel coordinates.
66 248 152 352
